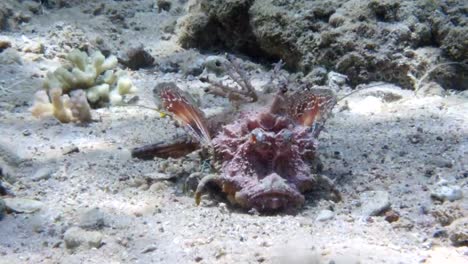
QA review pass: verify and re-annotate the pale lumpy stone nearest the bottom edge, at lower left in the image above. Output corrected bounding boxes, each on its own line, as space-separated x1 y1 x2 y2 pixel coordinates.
63 227 103 251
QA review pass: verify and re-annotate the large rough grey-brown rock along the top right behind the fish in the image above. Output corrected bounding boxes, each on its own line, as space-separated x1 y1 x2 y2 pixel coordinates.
179 0 468 89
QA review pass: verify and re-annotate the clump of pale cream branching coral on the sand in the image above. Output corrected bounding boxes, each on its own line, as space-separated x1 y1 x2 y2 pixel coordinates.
31 50 136 123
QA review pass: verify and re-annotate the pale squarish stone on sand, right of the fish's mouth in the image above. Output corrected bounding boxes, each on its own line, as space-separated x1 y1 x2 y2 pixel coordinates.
359 191 391 217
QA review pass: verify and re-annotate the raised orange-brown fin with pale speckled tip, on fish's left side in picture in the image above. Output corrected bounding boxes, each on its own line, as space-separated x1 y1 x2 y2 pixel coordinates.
157 83 211 144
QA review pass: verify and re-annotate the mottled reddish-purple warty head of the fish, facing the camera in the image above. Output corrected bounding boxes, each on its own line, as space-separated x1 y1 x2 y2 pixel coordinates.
212 112 317 211
